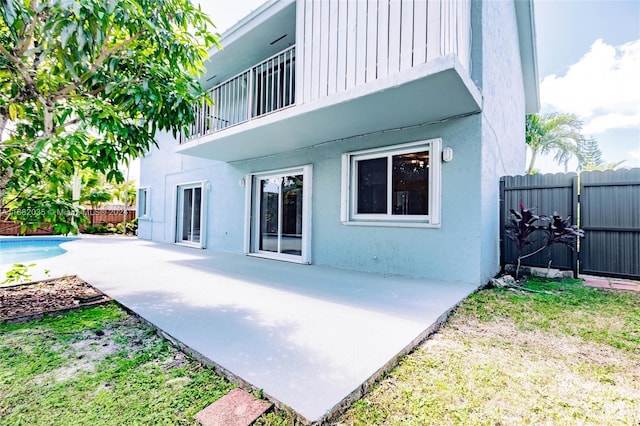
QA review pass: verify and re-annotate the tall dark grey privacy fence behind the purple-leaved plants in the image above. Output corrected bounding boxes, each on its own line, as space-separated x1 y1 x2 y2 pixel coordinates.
500 169 640 279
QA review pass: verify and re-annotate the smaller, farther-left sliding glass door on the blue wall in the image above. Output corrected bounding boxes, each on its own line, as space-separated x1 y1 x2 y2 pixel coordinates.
176 184 202 245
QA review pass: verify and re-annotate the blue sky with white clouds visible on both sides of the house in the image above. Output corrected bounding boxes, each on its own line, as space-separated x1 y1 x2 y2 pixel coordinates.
201 0 640 172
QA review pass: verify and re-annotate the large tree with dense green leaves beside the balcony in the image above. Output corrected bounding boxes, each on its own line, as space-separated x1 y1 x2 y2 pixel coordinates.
0 0 217 232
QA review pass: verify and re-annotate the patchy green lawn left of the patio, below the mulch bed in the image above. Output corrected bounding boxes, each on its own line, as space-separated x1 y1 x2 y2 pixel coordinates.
0 304 238 425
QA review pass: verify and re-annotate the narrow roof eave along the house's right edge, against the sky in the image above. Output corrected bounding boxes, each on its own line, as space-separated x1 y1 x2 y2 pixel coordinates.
515 0 540 114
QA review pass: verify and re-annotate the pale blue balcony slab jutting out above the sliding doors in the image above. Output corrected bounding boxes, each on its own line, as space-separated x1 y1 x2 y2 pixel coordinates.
177 55 482 162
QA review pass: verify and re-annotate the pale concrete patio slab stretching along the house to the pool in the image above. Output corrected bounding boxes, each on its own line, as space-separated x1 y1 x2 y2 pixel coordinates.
0 238 475 422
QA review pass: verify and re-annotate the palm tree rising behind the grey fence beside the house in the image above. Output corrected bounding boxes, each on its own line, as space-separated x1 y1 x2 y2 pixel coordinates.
526 113 585 174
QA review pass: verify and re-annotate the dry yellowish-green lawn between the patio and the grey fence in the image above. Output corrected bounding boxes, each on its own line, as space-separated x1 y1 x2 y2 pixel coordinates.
340 280 640 425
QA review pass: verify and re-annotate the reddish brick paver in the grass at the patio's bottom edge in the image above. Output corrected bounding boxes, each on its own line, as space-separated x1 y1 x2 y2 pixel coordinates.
196 389 272 426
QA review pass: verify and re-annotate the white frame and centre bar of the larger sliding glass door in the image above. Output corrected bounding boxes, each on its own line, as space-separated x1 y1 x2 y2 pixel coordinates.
245 165 312 264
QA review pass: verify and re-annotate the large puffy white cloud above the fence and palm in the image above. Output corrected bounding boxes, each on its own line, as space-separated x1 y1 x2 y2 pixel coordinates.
540 40 640 134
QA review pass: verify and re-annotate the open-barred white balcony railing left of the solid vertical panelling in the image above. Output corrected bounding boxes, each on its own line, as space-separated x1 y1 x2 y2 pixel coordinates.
182 46 296 142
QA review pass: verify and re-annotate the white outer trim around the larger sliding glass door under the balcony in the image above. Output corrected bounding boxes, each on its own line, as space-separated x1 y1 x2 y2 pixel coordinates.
244 164 313 264
